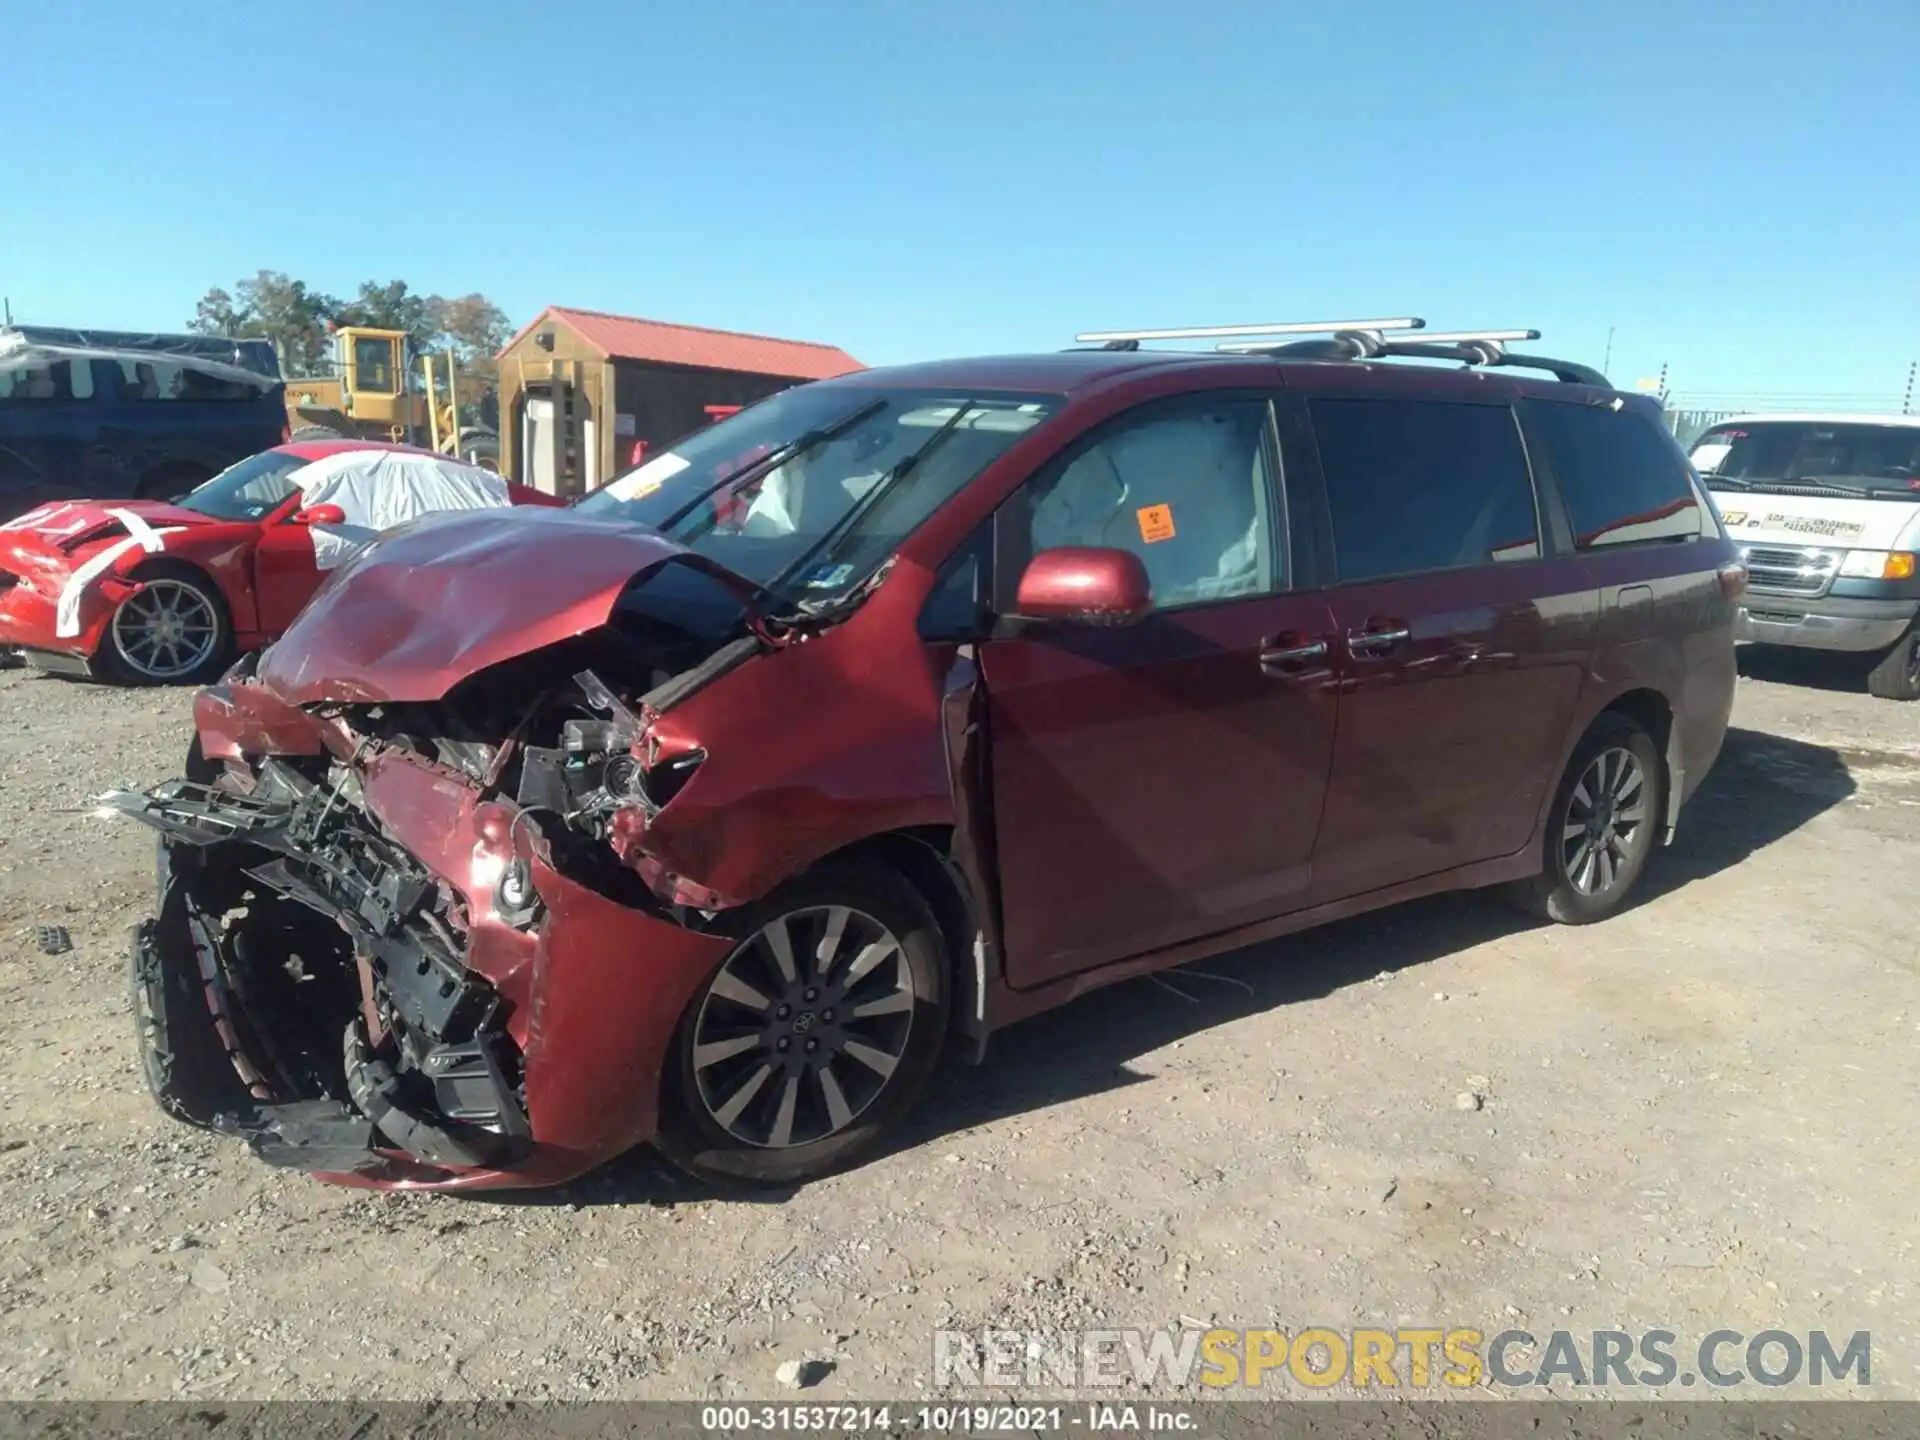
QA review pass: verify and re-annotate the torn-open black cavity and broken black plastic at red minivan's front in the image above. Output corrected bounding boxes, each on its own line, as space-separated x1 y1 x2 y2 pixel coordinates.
109 758 532 1171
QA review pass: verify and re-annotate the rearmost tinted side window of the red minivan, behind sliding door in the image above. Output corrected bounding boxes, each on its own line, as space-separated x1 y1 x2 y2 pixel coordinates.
1534 401 1701 549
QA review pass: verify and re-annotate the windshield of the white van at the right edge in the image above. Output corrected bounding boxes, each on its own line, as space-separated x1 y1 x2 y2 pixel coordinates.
1692 420 1920 497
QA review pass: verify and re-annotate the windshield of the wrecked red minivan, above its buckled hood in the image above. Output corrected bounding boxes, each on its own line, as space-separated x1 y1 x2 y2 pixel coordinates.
576 386 1062 609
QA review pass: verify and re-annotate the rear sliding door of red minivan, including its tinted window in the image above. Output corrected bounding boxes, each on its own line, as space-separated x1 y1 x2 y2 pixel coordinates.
1306 396 1596 902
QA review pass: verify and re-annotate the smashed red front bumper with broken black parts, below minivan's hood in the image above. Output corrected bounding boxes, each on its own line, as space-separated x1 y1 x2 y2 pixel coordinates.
117 687 728 1190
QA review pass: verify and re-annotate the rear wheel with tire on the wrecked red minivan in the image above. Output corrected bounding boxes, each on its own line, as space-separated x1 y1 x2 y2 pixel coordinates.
1507 710 1667 925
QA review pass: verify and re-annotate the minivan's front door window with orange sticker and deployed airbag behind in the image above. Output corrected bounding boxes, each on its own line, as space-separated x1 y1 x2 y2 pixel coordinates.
1027 397 1281 609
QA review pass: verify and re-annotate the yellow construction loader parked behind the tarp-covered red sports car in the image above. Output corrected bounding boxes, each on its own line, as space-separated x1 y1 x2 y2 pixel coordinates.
286 324 499 470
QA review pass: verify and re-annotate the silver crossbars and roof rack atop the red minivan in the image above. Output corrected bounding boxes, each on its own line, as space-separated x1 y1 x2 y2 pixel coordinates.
1073 317 1613 390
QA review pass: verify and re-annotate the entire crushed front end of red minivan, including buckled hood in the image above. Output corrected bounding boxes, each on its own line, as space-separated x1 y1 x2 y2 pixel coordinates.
102 511 947 1188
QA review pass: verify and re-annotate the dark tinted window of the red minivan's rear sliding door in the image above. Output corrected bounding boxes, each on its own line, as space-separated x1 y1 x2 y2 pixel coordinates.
1308 399 1540 580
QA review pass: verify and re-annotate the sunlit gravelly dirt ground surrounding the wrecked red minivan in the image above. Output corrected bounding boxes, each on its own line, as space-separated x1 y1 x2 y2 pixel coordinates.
0 648 1920 1398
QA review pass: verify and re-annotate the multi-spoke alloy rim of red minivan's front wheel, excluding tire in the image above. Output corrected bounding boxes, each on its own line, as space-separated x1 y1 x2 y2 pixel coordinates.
693 904 916 1150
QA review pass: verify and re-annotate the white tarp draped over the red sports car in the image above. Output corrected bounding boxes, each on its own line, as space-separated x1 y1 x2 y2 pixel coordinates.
288 449 513 570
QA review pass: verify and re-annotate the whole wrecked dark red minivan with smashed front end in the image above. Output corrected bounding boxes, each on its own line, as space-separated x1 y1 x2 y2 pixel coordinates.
111 323 1745 1188
